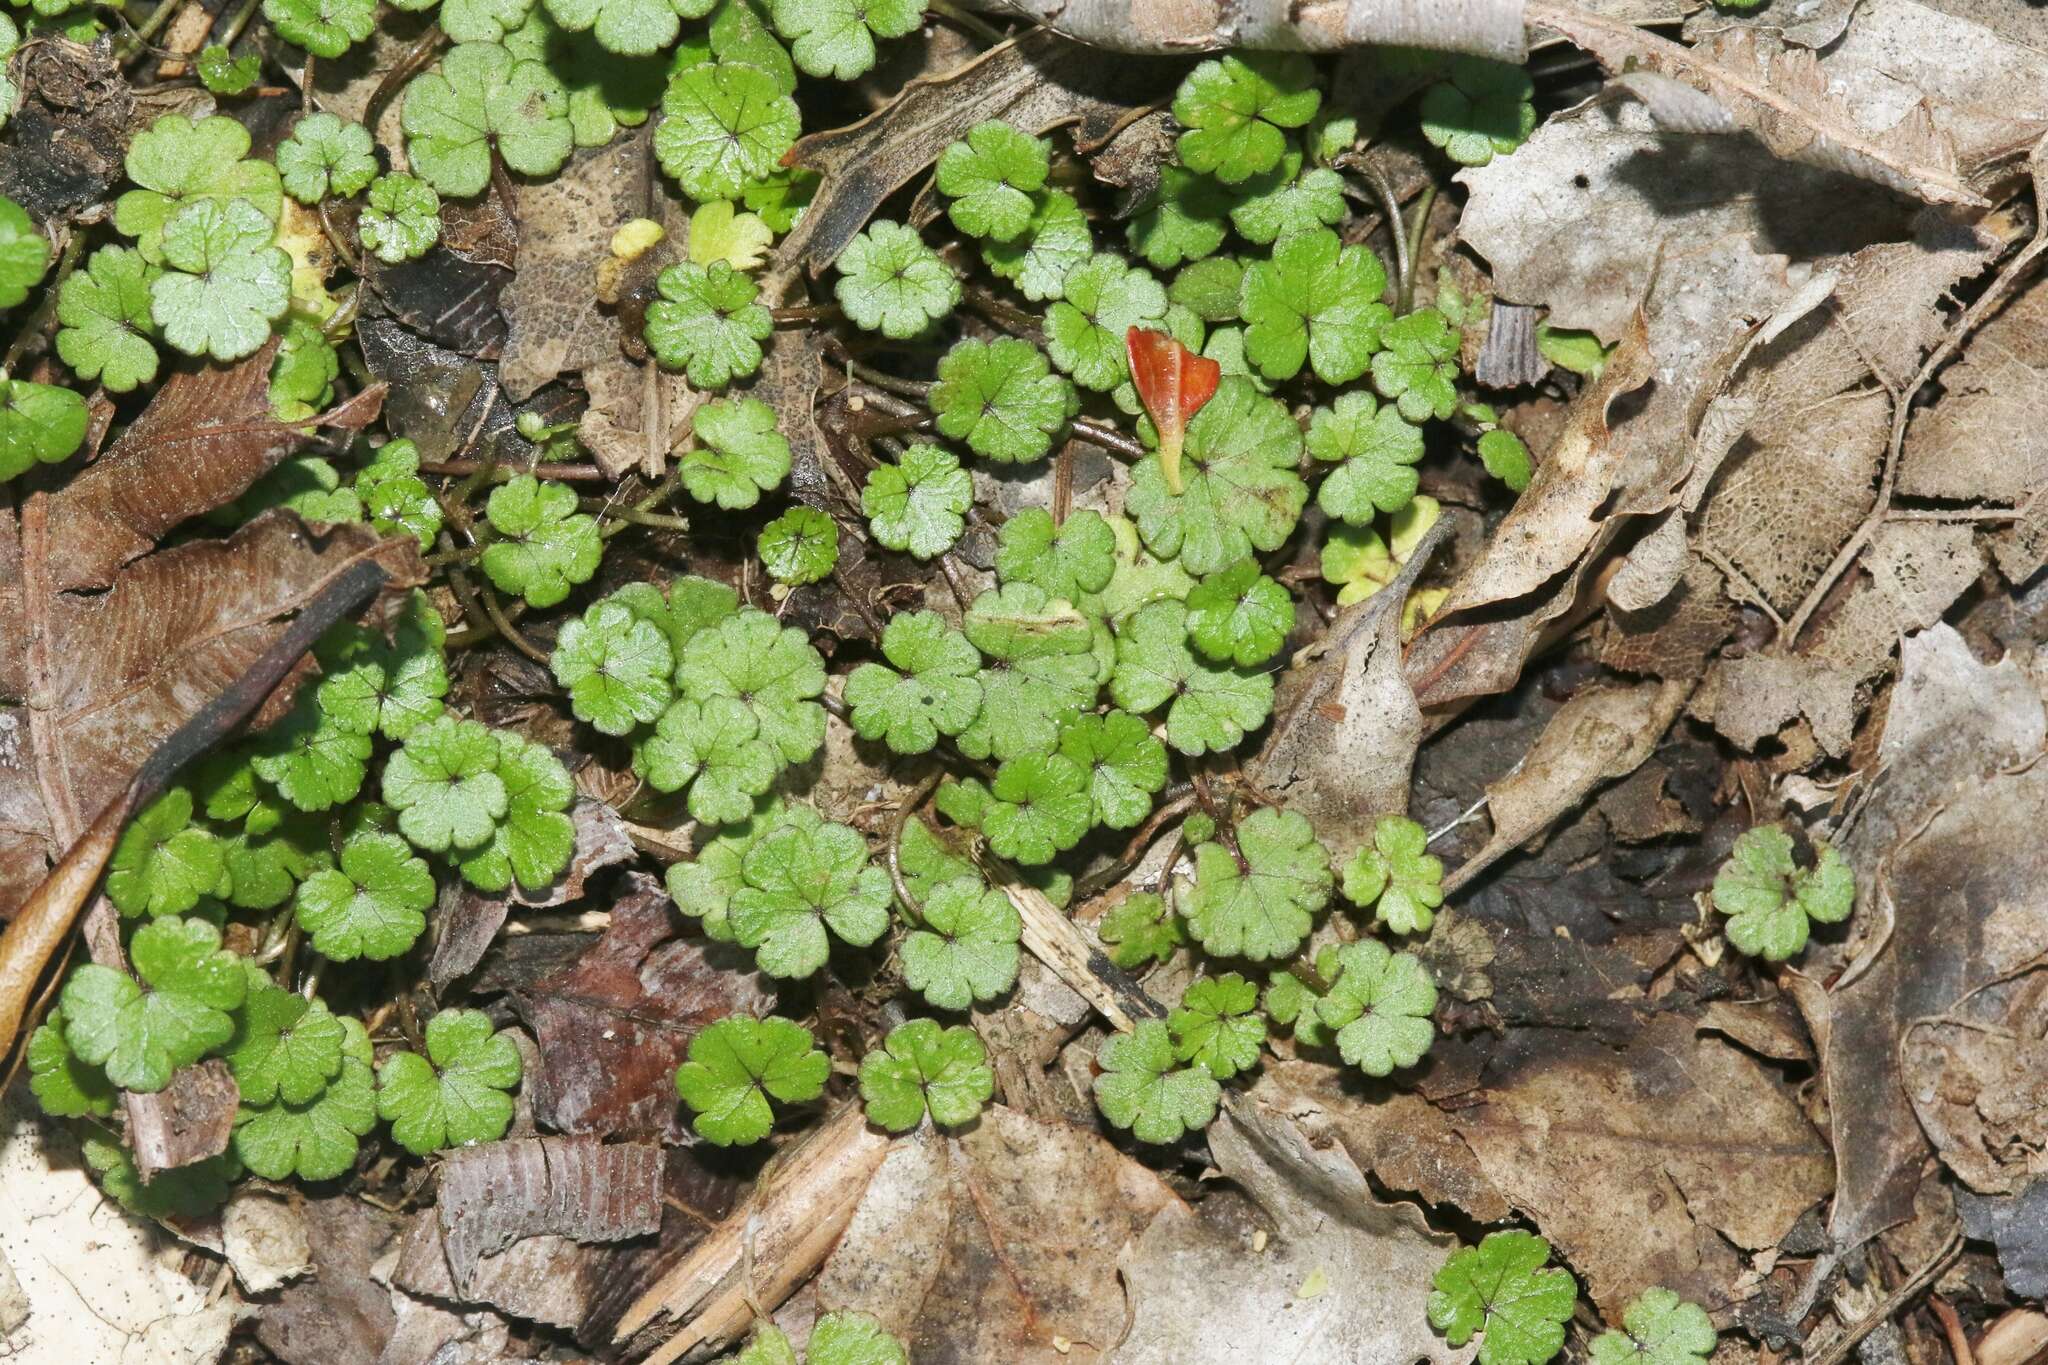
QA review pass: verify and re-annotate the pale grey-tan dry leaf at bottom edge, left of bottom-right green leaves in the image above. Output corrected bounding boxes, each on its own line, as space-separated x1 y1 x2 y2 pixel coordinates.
1108 1099 1466 1365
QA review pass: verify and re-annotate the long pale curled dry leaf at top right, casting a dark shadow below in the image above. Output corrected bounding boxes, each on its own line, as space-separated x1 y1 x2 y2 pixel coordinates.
1528 0 1987 205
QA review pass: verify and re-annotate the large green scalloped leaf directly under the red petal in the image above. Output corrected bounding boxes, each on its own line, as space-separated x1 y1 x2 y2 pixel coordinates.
1124 377 1309 573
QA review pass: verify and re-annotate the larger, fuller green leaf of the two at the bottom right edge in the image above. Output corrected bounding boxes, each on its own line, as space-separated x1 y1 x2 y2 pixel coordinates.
1430 1230 1579 1365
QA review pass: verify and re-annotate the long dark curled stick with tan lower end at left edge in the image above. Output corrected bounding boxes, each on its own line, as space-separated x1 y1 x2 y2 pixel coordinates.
0 559 389 1056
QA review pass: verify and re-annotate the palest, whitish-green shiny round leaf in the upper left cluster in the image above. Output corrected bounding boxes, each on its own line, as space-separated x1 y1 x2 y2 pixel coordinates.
150 199 291 360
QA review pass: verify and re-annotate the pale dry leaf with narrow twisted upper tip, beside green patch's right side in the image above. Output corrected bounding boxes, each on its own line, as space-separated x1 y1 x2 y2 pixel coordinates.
1251 518 1452 851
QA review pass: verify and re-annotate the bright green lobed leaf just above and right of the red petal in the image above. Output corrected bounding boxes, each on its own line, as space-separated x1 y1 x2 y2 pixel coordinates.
1239 227 1393 385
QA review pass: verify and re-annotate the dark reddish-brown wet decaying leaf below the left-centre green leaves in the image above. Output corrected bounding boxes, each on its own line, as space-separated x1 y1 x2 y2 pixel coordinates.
512 874 774 1142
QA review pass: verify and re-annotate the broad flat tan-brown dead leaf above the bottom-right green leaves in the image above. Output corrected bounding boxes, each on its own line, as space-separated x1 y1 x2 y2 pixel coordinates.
1450 1013 1833 1316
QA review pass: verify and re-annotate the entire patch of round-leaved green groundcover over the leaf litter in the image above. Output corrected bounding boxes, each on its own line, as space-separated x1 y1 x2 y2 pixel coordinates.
0 10 1597 1365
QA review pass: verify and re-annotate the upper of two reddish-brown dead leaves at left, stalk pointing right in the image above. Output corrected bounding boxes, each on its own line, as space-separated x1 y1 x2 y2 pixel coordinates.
49 342 385 591
